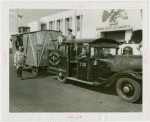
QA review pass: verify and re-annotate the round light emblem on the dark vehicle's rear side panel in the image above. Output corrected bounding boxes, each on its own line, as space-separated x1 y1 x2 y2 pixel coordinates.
49 51 60 65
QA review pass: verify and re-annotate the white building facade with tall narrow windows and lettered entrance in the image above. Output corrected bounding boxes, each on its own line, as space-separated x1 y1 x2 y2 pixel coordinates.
28 9 142 43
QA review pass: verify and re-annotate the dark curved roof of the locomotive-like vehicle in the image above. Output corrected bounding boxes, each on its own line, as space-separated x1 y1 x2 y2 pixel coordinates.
63 38 120 45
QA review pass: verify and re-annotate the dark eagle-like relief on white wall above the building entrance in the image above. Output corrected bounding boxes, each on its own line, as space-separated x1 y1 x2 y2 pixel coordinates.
102 9 128 26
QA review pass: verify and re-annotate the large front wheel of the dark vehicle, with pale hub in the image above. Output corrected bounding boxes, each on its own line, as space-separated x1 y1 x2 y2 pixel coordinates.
116 78 142 103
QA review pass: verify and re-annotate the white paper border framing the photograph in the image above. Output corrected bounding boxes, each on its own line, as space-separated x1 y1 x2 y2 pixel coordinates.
1 1 150 121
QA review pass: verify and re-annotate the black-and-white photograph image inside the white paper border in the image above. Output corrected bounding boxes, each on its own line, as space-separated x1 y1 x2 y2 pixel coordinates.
9 8 143 113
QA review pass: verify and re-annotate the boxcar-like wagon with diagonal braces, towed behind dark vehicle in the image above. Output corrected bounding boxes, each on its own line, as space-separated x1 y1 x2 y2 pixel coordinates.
12 30 59 75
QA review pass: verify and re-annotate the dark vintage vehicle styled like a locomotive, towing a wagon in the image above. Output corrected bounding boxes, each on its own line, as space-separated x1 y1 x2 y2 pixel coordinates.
48 38 142 102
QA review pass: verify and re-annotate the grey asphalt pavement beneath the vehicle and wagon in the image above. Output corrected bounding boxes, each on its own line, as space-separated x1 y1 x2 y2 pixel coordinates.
9 55 142 112
